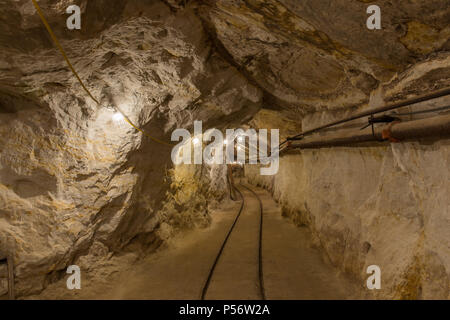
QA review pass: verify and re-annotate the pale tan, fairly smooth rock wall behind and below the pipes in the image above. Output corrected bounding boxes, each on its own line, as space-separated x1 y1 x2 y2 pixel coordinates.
245 55 450 299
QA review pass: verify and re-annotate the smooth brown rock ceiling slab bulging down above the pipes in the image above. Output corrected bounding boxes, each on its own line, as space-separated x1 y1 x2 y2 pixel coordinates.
198 0 450 111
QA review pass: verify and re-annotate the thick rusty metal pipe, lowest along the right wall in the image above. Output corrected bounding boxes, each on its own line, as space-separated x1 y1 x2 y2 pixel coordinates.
283 115 450 153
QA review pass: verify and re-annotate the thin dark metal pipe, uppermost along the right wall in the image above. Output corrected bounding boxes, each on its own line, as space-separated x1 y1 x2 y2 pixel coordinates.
287 88 450 140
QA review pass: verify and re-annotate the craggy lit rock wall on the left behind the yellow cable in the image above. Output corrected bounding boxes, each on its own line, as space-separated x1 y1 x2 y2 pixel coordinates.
0 0 262 296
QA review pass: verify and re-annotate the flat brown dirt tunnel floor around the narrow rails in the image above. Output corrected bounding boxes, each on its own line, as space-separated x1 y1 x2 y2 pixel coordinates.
31 182 361 299
